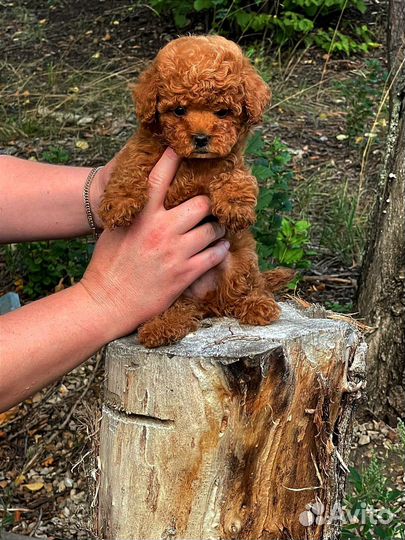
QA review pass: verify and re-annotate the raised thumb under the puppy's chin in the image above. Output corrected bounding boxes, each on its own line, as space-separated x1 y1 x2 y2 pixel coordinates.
148 147 181 208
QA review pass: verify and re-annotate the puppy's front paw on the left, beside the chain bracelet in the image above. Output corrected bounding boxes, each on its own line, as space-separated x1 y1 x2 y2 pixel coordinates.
98 195 146 229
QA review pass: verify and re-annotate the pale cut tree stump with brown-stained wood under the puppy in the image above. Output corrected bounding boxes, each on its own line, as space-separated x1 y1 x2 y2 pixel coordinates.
97 304 365 540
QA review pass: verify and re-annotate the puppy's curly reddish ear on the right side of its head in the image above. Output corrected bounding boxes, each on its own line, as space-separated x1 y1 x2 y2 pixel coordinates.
243 58 271 126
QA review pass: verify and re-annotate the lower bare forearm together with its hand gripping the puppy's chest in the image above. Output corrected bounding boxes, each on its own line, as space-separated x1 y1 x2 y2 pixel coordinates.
0 150 229 411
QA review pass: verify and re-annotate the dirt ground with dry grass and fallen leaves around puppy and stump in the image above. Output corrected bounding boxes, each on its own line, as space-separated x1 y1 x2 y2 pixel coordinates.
0 0 399 540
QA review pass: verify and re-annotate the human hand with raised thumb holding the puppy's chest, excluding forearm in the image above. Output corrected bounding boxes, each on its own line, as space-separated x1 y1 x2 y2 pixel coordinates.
80 149 229 339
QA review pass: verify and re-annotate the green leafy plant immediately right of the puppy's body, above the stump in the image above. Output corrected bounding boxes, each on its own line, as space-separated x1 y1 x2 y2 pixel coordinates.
246 132 310 269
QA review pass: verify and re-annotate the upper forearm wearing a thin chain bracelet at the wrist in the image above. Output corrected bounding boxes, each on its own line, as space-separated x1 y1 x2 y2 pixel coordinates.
0 156 104 243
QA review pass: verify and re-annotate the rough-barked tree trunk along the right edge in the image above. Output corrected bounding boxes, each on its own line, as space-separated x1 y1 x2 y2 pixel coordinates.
358 0 405 423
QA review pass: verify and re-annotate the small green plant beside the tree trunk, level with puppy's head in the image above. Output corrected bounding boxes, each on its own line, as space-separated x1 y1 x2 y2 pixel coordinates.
335 60 387 144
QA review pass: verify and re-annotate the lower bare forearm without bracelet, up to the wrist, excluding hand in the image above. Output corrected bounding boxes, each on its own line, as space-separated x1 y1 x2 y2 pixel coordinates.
0 283 128 412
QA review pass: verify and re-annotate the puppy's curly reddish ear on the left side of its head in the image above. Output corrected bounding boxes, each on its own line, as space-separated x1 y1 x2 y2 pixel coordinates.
130 63 158 126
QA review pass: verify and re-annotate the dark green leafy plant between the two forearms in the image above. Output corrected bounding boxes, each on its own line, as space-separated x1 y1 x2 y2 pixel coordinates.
3 240 92 300
